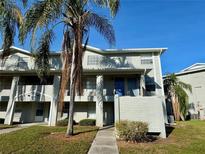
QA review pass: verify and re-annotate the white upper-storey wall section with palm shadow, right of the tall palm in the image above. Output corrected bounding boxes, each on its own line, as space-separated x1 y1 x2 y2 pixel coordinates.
83 53 153 72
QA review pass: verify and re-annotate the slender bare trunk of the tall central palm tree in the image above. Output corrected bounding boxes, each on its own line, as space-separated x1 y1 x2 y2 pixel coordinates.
66 41 76 136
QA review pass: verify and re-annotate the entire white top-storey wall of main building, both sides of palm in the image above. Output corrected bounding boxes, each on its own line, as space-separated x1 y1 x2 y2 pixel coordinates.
0 47 154 72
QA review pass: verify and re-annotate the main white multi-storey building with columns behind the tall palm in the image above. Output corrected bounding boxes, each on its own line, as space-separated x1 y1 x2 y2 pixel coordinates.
0 47 167 137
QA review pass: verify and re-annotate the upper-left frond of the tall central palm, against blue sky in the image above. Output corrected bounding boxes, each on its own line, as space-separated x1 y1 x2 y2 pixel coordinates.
19 0 63 42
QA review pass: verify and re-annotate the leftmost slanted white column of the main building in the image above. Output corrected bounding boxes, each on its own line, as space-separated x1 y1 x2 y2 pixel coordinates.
4 77 19 125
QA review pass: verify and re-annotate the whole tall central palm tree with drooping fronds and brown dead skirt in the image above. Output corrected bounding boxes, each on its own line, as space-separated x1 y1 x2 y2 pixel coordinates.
21 0 119 136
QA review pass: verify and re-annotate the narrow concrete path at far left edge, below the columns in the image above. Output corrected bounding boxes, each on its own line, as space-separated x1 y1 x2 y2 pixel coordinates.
0 123 45 134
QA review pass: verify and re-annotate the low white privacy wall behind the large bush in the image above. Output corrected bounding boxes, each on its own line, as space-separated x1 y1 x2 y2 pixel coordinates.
115 96 166 138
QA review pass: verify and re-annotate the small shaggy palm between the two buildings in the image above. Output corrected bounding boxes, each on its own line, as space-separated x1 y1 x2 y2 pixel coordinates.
164 74 192 120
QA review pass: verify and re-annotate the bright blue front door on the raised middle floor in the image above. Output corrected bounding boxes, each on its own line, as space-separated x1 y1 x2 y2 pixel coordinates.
115 78 125 96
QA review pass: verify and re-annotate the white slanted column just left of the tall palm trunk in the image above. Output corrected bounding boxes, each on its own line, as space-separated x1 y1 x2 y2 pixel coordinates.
48 76 60 126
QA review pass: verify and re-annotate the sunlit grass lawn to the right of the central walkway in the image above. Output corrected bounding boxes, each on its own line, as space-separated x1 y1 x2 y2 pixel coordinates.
118 121 205 154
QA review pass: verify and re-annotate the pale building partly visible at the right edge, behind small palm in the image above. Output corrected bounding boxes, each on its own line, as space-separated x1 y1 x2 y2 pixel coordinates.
171 63 205 120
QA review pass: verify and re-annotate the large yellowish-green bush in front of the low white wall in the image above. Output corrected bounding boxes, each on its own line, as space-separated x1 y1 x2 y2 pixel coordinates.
115 120 148 142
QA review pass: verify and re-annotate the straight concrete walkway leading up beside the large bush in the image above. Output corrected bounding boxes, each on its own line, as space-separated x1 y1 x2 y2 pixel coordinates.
88 127 119 154
